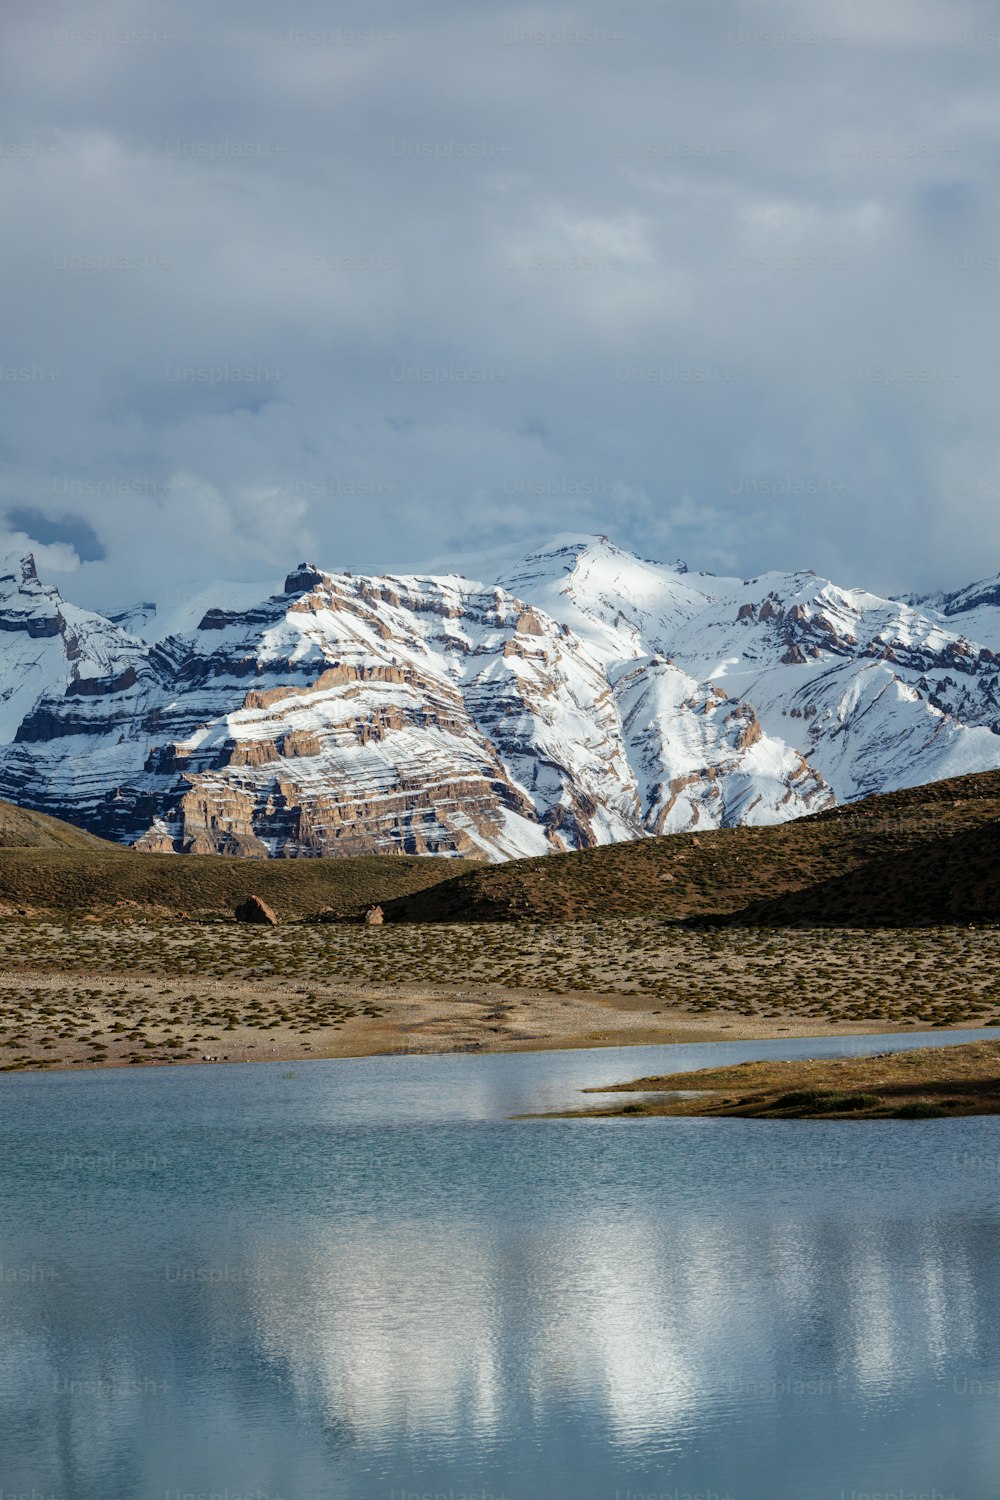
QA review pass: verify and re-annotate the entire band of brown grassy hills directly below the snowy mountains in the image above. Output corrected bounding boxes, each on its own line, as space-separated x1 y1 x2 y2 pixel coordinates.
0 771 1000 927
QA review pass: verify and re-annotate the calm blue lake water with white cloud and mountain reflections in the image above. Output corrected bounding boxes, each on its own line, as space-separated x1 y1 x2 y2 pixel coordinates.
0 1032 1000 1500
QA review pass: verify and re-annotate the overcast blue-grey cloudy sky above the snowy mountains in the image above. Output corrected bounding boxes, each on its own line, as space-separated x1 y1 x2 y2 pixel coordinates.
0 0 1000 606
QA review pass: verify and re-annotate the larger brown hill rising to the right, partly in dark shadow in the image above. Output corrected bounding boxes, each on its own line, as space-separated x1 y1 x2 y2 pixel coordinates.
385 771 1000 926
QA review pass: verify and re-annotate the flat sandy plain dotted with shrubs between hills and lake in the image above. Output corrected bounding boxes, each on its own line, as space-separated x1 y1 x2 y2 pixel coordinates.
0 918 1000 1071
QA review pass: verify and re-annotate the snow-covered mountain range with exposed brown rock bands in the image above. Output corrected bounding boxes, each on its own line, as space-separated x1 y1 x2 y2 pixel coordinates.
0 537 1000 860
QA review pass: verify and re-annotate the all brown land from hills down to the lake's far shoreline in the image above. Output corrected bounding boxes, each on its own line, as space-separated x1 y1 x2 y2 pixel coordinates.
0 773 1000 1074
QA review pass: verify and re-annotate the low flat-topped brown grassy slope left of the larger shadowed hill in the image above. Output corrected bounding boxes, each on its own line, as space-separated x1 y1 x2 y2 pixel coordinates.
0 852 453 921
